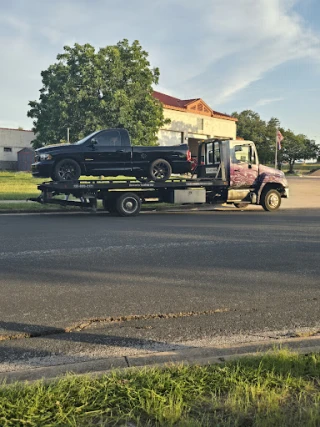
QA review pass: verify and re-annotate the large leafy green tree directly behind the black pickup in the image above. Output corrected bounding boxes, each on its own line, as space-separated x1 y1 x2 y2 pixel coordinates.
27 39 167 148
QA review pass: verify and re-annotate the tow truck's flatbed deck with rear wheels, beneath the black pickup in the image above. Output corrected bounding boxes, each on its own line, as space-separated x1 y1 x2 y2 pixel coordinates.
29 178 228 216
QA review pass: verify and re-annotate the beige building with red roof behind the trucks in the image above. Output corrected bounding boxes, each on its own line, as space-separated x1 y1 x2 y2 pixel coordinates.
153 92 237 156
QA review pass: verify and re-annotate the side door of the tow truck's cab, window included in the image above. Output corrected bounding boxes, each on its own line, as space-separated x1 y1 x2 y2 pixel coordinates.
230 142 259 188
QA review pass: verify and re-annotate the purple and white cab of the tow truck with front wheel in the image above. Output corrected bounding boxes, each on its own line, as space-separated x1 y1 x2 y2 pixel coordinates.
194 139 289 210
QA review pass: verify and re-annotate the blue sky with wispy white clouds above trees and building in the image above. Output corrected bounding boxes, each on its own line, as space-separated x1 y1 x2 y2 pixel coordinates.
0 0 320 143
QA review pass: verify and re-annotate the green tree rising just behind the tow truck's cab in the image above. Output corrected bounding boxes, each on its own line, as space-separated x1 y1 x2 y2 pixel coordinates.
232 110 279 163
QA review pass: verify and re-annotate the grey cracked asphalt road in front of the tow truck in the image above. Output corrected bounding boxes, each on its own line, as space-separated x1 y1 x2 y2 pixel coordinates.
0 180 320 372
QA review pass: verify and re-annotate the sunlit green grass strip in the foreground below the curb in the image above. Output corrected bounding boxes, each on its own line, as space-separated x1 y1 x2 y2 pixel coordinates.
0 350 320 427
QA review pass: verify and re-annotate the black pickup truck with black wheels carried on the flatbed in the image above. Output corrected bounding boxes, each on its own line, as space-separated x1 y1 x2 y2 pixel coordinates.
32 129 191 181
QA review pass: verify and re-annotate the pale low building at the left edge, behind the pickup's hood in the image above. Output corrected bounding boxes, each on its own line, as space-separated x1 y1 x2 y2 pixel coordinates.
0 128 34 170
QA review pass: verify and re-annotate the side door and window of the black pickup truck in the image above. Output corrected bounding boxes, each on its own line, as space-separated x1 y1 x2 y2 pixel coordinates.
84 130 131 176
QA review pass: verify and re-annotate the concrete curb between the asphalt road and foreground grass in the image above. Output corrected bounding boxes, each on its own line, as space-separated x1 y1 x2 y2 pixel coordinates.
0 336 320 385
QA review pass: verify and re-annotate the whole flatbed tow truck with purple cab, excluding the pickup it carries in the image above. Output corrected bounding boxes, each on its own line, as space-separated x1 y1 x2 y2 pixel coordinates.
29 139 289 216
